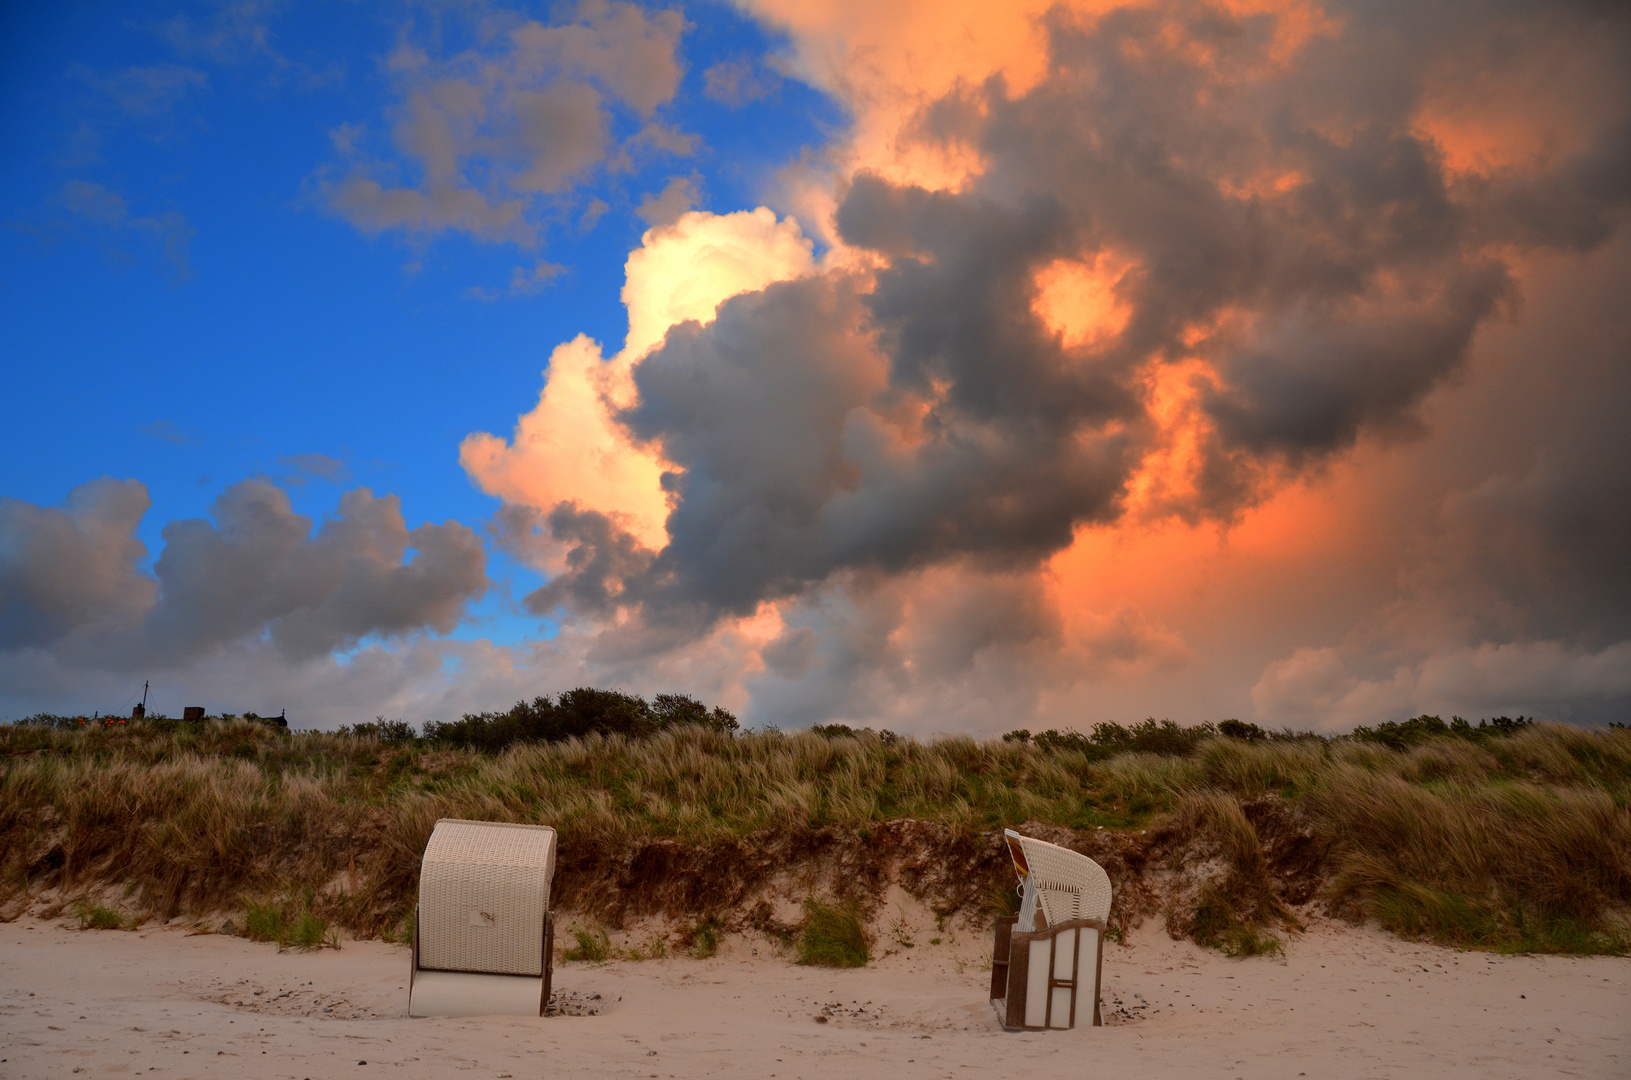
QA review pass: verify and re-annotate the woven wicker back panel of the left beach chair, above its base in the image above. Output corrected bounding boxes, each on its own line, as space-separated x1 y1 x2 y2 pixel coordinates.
419 817 555 976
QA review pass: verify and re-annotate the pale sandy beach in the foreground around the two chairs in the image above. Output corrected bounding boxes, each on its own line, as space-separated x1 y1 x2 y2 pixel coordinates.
0 918 1631 1080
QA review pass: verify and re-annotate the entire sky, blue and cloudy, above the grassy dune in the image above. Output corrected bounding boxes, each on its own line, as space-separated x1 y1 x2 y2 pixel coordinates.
0 0 1631 736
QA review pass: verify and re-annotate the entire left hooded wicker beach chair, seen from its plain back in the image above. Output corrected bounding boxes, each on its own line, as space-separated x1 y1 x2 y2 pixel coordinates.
408 817 555 1016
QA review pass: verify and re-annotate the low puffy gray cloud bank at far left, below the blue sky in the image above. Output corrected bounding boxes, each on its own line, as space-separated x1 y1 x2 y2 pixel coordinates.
0 480 488 667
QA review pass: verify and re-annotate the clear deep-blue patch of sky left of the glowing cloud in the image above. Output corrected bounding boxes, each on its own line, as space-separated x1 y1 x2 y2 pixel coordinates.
0 3 845 641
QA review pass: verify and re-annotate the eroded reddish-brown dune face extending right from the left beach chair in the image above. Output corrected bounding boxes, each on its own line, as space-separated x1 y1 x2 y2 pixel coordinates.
556 796 1326 936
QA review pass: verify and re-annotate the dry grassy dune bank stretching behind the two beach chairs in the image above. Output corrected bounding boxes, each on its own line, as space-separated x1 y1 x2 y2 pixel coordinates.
0 721 1631 953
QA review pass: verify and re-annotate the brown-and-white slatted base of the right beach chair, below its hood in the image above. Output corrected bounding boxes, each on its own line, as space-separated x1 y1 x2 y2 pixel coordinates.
992 915 1104 1031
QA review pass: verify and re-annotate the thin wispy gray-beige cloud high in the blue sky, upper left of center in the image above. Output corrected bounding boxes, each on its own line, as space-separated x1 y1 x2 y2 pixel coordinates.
315 0 693 246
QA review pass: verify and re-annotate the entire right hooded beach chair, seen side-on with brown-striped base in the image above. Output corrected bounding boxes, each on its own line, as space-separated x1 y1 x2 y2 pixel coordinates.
992 829 1111 1031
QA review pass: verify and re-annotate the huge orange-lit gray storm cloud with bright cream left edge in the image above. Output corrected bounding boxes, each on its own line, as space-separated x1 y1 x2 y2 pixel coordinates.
465 0 1631 729
